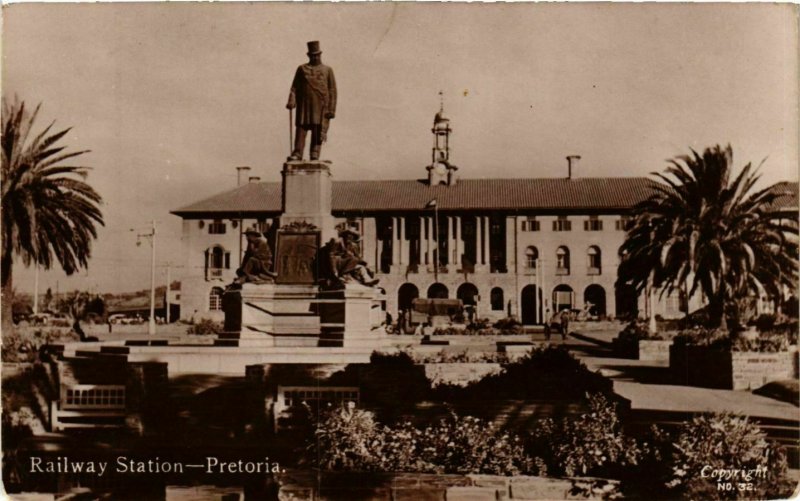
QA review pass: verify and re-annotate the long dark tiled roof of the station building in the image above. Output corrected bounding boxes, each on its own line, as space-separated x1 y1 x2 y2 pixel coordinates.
172 177 654 217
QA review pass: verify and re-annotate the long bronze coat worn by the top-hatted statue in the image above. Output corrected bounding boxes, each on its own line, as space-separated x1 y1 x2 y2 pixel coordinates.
289 64 336 127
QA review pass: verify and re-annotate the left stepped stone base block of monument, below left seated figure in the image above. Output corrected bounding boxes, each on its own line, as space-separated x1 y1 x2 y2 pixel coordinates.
216 284 321 346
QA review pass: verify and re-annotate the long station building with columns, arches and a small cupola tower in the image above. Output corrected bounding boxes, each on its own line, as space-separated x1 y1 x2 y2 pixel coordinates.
173 110 796 324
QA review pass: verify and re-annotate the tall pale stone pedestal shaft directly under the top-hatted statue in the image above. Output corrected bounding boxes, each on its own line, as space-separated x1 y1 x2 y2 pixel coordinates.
280 160 336 244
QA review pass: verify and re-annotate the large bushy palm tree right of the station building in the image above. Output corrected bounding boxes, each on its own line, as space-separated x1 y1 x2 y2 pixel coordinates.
619 145 798 328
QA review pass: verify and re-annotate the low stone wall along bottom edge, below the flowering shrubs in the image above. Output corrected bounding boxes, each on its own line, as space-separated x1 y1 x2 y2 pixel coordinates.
277 471 619 501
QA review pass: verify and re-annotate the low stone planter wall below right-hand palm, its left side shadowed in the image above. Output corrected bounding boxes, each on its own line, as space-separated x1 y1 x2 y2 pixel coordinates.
669 345 798 390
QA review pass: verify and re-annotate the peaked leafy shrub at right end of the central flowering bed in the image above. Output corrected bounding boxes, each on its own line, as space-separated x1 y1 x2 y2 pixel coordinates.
529 394 640 477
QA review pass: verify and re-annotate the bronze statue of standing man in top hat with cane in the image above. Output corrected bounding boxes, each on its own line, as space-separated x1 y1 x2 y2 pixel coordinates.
286 41 336 160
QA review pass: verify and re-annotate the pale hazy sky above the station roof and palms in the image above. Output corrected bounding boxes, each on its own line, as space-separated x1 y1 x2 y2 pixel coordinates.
2 2 798 292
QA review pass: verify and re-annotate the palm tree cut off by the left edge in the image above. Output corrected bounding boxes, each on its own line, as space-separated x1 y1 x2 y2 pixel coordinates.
0 99 103 332
